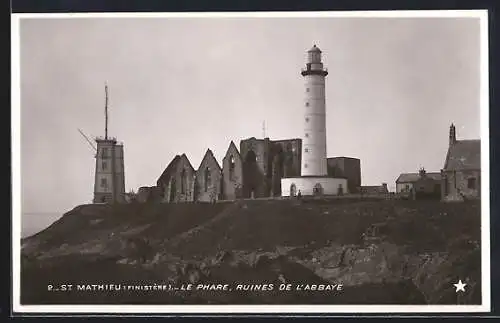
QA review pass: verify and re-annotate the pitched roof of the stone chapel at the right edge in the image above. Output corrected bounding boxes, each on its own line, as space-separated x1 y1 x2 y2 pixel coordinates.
444 139 481 170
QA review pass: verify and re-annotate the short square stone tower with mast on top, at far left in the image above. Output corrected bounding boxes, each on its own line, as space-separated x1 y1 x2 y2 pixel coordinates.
93 85 125 203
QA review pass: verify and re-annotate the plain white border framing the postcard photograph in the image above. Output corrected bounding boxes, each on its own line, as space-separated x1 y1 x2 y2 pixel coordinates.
11 10 491 314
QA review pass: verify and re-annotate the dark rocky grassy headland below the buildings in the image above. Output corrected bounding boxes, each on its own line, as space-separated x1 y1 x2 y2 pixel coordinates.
21 200 481 304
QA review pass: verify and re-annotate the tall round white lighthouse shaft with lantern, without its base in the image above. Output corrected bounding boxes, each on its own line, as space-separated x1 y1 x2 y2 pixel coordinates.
301 45 328 176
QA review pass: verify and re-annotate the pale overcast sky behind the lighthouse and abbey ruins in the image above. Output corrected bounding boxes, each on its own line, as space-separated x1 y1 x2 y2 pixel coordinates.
20 18 480 237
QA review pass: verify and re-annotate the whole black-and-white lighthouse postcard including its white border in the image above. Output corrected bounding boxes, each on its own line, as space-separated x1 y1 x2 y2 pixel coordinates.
11 10 490 313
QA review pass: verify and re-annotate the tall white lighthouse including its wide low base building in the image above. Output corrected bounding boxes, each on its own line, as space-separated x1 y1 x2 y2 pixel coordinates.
281 45 349 196
